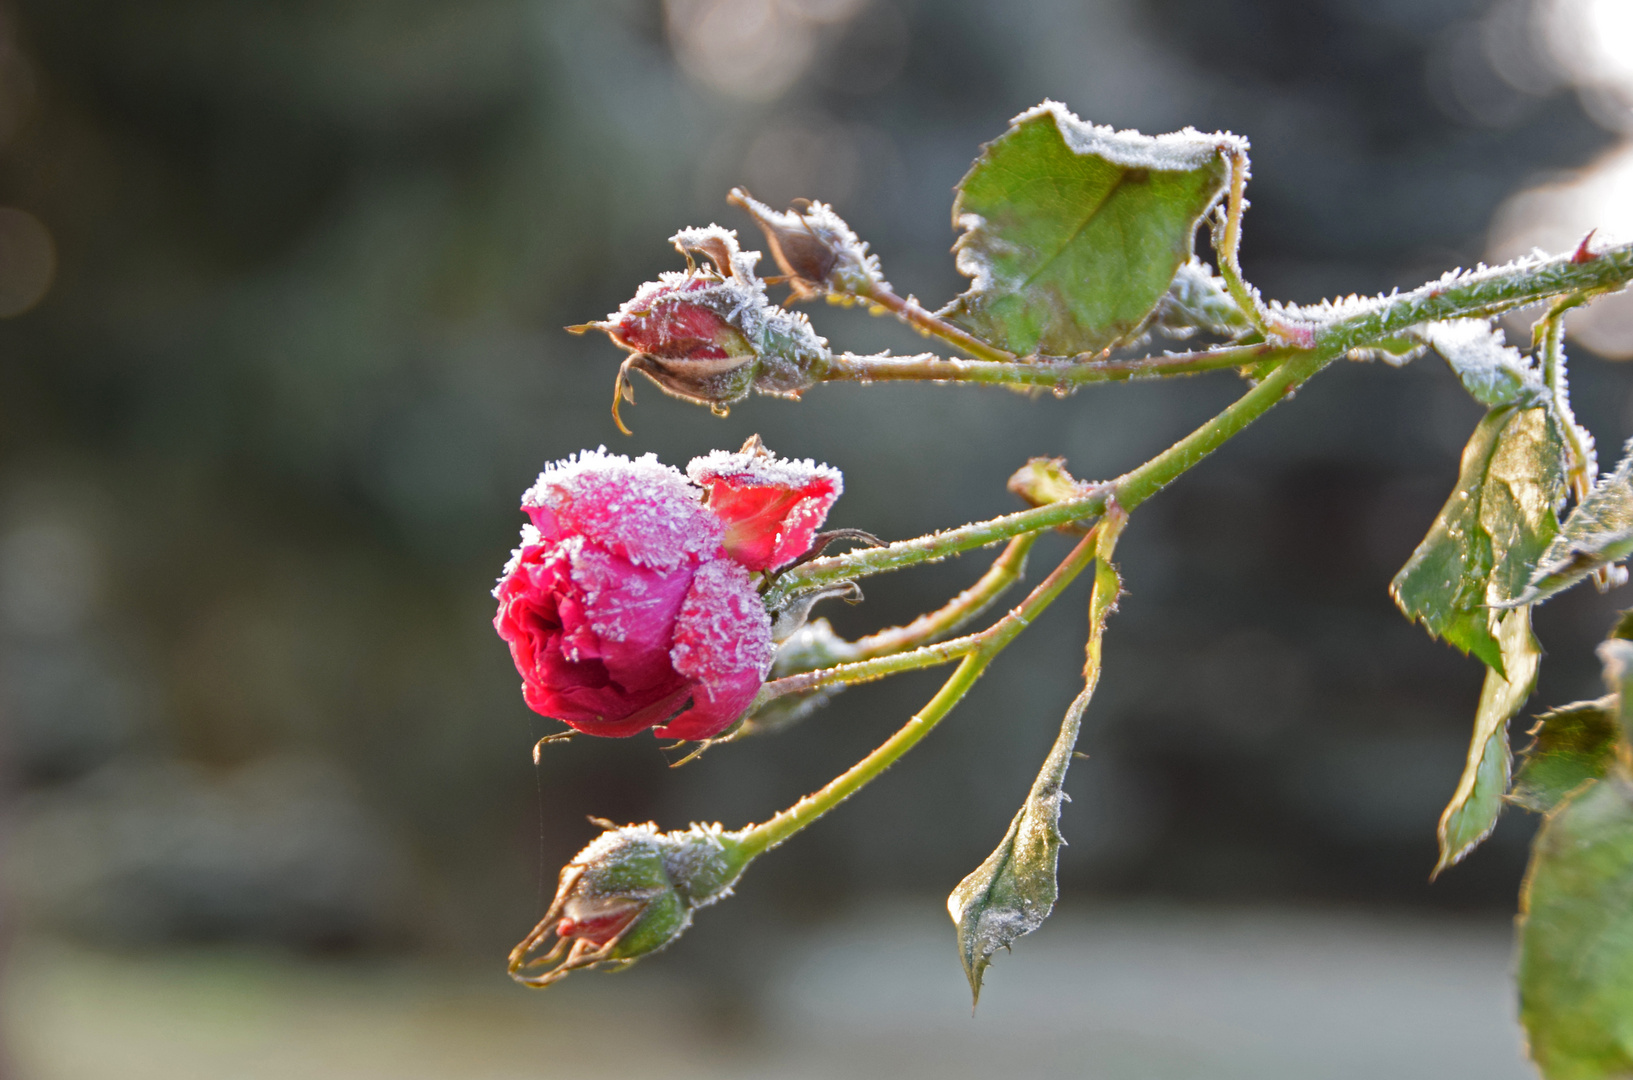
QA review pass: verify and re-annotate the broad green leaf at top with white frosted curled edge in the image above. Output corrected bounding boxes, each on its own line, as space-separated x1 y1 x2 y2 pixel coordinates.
941 101 1246 356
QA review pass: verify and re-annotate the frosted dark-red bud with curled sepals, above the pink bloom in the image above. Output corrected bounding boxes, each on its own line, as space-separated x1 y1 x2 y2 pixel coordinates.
568 225 828 435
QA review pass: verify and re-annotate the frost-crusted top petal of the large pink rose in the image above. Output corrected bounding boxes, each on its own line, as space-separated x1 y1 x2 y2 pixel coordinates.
521 446 720 570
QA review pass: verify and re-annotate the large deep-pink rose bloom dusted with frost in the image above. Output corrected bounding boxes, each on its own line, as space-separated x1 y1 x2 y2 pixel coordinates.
493 451 774 740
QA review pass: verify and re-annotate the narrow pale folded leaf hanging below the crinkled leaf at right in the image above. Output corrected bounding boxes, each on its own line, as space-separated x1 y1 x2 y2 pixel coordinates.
1434 608 1542 874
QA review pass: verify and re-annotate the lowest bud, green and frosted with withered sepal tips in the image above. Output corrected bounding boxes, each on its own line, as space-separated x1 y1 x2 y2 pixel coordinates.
509 823 750 987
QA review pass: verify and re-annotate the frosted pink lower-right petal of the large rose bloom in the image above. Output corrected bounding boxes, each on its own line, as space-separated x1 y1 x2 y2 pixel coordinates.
658 559 776 739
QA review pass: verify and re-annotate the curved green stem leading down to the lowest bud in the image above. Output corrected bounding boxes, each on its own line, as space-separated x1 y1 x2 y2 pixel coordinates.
738 526 1099 861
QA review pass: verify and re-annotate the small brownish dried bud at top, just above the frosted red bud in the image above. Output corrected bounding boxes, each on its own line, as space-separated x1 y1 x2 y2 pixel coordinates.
727 188 890 299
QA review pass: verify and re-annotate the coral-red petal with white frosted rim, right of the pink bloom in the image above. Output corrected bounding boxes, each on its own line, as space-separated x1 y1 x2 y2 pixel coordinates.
686 440 844 570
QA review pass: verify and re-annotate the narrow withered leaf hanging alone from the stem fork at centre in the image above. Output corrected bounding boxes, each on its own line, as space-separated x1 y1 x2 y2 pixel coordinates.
947 559 1120 1002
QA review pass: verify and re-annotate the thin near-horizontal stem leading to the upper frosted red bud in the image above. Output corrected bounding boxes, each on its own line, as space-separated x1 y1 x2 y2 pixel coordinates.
823 343 1290 390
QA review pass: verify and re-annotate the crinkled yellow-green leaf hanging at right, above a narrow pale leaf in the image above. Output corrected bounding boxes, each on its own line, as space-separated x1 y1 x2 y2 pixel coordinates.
1390 405 1564 675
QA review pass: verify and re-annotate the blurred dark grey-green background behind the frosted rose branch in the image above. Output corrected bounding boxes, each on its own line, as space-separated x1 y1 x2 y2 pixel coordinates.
0 0 1633 1077
